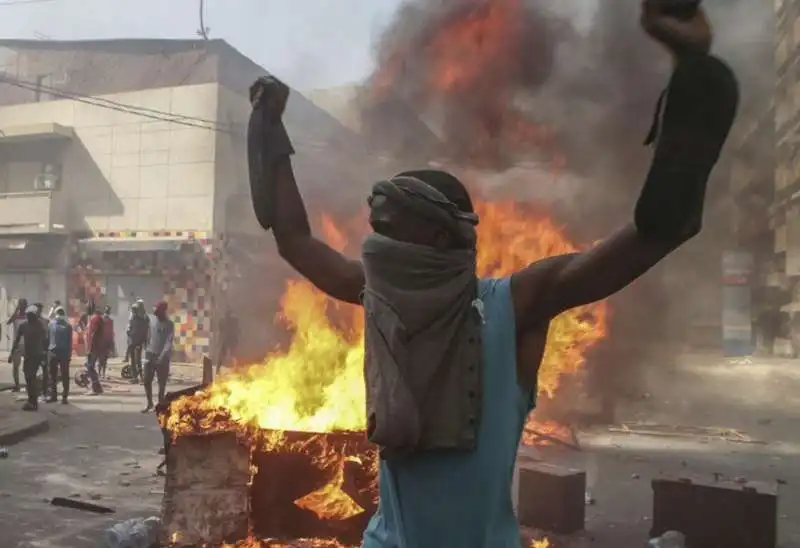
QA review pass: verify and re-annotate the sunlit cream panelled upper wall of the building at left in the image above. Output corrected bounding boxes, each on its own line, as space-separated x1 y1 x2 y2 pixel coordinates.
0 84 220 231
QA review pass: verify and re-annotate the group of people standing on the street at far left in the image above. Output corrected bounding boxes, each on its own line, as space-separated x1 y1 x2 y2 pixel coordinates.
6 298 175 413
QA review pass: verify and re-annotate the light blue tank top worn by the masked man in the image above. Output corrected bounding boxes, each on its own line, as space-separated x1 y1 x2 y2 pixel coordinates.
363 278 535 548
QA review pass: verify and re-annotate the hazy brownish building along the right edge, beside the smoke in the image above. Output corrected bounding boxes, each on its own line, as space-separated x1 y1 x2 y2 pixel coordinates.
724 0 800 354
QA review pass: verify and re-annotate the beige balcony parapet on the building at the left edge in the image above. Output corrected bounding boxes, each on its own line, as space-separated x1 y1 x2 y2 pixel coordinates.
0 190 67 235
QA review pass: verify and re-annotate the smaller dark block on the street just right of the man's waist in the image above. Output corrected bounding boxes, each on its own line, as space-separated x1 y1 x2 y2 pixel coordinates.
517 460 586 535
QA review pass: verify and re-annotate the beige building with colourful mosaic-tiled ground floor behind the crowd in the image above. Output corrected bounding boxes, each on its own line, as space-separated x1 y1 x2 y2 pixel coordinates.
0 40 365 359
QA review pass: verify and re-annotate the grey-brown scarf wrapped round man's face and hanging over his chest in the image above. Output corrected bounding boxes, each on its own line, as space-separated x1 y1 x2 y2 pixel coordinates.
362 177 482 458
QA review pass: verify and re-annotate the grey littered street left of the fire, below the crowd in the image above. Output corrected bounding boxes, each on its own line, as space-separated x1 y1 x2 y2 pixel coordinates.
0 360 195 548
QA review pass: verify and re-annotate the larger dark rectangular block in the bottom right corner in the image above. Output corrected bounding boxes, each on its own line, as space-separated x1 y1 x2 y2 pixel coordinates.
650 478 778 548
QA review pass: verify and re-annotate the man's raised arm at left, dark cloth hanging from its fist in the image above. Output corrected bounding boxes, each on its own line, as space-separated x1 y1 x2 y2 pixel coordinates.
248 78 364 304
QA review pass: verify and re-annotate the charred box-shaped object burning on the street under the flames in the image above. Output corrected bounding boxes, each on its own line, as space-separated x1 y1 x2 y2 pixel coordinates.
162 400 378 546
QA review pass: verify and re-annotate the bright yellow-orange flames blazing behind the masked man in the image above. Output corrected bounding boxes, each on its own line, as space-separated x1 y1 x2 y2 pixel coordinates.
165 197 606 544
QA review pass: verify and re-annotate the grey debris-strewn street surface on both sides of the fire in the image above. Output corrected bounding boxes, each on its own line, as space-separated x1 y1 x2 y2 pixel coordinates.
0 356 800 548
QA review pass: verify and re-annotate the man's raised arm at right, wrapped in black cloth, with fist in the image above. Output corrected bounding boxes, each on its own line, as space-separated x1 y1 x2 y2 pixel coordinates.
511 0 739 332
